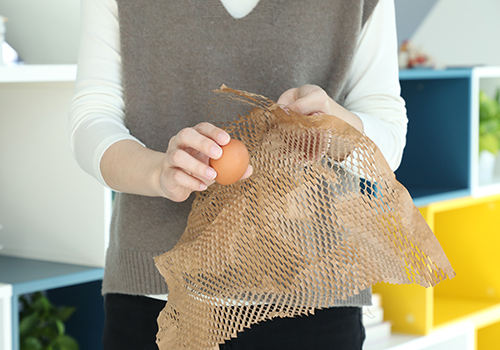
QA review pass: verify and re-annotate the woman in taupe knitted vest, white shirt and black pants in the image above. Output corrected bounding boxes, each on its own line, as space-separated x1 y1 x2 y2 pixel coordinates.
70 0 407 350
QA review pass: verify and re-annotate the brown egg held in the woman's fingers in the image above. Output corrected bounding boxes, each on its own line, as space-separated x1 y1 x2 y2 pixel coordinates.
209 139 250 185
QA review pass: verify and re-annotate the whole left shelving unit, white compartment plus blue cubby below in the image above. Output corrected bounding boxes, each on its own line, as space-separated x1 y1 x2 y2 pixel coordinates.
0 65 112 350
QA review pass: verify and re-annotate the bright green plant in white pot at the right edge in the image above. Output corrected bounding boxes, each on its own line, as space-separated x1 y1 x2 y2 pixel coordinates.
478 89 500 182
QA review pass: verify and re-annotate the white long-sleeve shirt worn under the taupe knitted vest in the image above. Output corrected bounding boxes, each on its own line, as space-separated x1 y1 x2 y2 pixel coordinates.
69 0 407 186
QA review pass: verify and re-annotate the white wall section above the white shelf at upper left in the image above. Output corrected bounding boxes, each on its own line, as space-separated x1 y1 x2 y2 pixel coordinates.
0 0 80 64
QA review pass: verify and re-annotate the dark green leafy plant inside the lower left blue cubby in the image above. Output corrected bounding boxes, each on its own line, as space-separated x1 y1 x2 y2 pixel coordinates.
19 292 79 350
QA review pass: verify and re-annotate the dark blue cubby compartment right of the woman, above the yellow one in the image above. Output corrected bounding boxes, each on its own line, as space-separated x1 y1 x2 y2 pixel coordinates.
396 70 471 204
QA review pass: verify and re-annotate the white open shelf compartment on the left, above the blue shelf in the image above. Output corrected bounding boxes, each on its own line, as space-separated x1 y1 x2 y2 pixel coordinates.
0 65 111 267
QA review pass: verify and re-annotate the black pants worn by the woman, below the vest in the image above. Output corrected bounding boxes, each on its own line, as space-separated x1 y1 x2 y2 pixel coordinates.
103 294 365 350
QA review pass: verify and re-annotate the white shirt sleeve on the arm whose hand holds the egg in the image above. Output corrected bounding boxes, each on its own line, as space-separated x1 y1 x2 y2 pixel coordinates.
69 0 142 187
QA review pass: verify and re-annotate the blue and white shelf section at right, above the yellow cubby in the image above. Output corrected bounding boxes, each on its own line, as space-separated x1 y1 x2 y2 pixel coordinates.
396 67 500 206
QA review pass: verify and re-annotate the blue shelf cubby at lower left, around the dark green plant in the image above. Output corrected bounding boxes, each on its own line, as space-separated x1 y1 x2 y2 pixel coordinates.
0 255 104 350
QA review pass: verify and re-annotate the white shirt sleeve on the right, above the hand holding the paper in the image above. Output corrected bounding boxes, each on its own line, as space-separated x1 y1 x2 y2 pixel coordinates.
344 0 408 171
